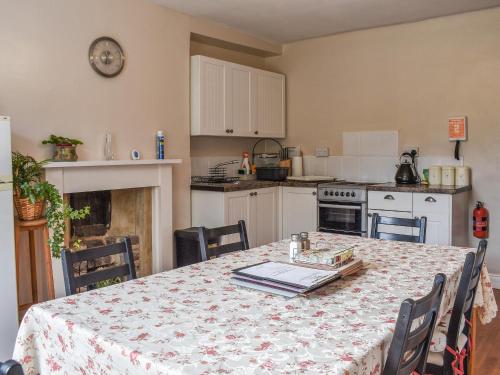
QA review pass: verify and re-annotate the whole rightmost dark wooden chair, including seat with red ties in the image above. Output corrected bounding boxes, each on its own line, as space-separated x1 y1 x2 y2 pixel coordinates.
427 240 488 375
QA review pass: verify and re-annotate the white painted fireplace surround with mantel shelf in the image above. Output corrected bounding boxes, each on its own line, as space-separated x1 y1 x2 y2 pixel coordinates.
45 159 182 297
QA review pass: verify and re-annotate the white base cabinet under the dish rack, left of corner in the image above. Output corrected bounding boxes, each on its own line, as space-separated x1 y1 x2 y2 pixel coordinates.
191 187 278 247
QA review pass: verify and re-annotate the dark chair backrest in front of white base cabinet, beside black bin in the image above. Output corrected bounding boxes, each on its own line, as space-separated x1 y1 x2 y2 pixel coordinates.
198 220 250 261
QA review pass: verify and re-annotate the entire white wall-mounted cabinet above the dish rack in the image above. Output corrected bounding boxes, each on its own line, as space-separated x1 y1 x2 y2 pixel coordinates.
191 56 285 138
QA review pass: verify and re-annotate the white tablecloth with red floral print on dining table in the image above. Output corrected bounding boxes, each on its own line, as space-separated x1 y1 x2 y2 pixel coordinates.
14 233 496 375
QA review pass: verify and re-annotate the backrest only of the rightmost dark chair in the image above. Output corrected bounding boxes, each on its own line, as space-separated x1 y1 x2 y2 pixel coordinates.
443 240 488 368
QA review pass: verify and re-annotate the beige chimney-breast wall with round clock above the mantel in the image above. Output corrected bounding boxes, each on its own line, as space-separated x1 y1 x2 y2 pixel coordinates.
0 0 281 298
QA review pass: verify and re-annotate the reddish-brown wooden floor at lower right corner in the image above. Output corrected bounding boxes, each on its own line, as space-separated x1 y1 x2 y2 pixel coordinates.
475 289 500 375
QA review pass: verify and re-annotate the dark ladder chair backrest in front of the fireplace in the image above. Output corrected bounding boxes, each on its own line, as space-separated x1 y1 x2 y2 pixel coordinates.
61 237 136 296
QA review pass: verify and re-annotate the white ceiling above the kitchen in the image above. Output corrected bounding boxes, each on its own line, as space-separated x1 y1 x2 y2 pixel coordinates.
154 0 500 43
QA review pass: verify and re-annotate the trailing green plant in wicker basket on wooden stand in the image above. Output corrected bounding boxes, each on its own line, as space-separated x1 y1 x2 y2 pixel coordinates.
12 152 90 258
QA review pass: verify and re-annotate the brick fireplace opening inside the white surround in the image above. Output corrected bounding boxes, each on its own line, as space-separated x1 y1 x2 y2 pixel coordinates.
65 188 152 277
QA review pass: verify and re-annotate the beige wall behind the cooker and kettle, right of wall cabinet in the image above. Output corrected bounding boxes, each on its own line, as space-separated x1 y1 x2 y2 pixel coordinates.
267 8 500 273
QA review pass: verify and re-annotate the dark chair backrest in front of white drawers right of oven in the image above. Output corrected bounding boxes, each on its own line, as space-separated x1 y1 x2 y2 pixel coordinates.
370 214 427 243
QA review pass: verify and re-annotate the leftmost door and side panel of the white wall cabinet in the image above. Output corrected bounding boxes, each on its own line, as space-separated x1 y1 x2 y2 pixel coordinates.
191 56 227 135
